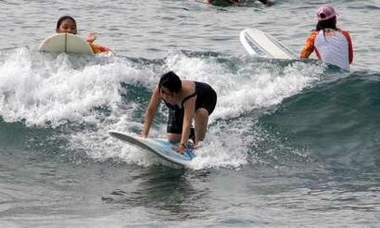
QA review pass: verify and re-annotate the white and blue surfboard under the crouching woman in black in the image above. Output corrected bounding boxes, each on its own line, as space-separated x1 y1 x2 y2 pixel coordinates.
109 131 195 167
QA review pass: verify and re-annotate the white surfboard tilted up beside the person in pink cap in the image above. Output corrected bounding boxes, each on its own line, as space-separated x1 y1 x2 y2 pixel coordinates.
240 28 298 59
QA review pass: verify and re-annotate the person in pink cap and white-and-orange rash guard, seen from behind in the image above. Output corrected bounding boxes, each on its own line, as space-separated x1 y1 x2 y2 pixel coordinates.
300 4 354 71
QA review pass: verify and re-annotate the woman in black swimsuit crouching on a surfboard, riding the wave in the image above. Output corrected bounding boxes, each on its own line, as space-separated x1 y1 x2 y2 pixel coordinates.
141 71 217 154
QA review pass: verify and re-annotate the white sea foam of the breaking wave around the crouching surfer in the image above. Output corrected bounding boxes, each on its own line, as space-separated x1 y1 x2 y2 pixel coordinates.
0 48 323 169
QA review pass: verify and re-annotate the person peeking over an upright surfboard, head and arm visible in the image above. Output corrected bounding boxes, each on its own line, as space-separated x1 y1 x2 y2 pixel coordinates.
55 16 112 54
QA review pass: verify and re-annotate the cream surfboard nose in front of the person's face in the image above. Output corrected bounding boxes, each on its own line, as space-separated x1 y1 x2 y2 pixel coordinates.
38 33 94 55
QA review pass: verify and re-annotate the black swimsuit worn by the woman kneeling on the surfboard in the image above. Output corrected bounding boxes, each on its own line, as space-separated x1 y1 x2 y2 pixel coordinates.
164 82 217 134
